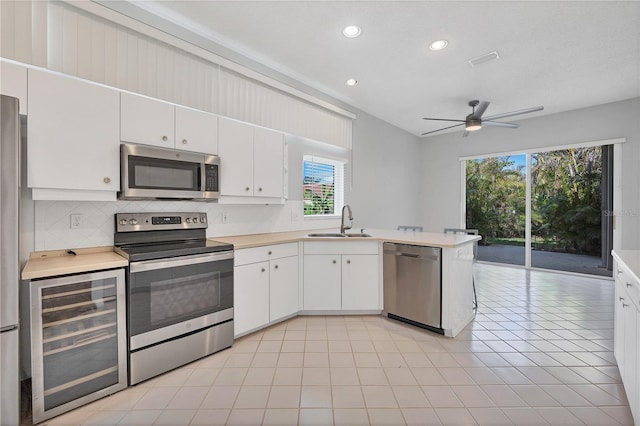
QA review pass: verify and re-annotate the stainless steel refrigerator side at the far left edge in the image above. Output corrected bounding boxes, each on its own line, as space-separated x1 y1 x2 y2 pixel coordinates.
0 95 21 426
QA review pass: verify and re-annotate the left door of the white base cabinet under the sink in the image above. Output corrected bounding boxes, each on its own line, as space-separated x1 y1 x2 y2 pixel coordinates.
303 254 342 311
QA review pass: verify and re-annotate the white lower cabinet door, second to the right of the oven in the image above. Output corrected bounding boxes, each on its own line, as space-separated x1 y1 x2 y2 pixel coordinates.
269 256 298 321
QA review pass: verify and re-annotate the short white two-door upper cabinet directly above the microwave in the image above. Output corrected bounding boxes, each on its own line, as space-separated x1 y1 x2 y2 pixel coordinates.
120 93 218 155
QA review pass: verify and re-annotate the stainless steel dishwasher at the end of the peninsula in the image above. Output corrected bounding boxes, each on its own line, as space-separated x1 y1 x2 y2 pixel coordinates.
383 243 444 334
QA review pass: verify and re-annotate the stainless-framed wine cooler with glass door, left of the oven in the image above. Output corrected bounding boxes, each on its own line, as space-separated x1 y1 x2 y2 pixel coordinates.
30 269 127 424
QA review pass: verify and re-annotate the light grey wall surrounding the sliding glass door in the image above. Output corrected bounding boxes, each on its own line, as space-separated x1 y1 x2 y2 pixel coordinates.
421 98 640 249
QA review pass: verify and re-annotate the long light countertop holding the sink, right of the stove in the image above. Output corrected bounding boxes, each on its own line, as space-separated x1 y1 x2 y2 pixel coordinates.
210 228 482 249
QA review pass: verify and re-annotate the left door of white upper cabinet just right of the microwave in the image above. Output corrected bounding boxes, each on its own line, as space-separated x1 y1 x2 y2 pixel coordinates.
218 117 253 196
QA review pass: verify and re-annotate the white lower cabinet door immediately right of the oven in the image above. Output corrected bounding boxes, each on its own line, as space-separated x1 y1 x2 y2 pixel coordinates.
233 262 269 336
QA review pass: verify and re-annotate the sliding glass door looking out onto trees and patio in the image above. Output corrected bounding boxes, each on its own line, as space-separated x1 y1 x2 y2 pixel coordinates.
465 146 612 276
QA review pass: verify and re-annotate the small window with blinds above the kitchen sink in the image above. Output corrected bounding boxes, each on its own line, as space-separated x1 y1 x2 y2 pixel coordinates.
302 155 345 217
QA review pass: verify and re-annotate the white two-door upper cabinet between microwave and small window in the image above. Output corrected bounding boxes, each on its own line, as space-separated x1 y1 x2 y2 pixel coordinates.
218 117 285 203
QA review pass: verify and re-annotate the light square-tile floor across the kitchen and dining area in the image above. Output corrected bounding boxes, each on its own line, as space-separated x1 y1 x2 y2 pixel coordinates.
42 264 633 425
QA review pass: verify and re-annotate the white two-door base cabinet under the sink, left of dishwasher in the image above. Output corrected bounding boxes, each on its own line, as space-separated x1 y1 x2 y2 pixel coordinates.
303 241 382 311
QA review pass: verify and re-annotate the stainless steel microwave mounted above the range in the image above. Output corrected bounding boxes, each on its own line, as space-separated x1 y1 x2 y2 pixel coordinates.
118 144 220 201
